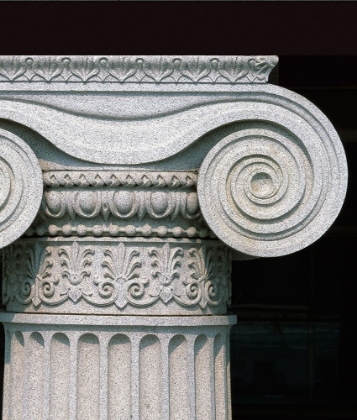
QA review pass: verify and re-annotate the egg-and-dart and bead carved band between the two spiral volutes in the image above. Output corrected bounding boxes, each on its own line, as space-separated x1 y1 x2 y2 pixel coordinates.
26 171 215 238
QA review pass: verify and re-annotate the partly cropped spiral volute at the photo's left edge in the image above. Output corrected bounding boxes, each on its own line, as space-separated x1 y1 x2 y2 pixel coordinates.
0 129 43 248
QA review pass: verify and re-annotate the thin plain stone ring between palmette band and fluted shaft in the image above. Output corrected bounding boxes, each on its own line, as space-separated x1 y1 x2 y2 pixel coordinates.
0 312 237 327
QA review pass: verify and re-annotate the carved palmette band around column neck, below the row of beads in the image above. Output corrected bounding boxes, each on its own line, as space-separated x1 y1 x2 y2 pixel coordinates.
3 238 230 315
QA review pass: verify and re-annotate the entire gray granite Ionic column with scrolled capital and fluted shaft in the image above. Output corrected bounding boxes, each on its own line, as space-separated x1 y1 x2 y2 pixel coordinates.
0 56 347 420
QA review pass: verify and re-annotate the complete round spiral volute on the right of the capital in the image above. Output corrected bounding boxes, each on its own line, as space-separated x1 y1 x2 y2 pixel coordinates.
198 121 347 257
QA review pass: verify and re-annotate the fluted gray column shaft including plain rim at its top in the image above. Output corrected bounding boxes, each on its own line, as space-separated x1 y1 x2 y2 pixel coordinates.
2 313 235 420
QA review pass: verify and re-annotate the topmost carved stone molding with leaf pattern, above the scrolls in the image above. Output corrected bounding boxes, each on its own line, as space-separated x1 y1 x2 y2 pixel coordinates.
0 55 278 84
